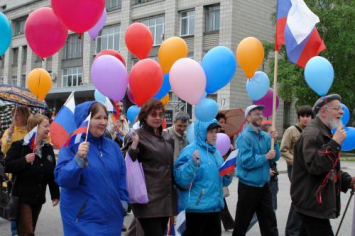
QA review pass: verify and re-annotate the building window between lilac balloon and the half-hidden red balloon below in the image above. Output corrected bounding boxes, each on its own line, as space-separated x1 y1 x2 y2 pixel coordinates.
96 25 121 54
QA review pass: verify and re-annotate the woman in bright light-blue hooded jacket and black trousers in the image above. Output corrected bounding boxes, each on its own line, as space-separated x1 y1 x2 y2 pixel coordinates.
174 119 234 236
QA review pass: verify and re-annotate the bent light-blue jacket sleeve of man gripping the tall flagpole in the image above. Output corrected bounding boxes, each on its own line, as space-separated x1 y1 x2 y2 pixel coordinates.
235 135 267 169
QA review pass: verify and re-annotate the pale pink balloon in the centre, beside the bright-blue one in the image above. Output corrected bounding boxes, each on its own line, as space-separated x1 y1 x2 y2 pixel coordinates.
169 58 206 105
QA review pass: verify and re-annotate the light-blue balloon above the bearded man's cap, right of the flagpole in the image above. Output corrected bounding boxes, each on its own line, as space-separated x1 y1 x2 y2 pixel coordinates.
304 56 334 96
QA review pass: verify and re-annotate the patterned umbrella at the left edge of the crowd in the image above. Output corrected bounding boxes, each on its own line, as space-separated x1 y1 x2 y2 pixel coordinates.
0 84 46 108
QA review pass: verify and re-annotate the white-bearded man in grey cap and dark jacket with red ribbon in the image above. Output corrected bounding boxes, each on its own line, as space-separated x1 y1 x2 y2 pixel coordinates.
291 94 355 236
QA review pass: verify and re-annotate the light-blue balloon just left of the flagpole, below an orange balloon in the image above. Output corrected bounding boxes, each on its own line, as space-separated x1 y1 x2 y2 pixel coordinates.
245 71 270 101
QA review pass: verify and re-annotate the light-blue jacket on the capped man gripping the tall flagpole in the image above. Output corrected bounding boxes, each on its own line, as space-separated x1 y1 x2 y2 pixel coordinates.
235 125 280 187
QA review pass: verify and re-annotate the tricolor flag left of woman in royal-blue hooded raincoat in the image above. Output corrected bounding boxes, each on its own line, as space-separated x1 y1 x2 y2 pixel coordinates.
50 92 76 148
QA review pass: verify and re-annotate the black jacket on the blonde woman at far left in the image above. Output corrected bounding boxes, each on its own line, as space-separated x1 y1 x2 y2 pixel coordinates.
5 140 59 205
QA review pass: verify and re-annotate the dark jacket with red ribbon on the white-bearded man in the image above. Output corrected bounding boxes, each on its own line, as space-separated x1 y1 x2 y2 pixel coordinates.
291 117 351 219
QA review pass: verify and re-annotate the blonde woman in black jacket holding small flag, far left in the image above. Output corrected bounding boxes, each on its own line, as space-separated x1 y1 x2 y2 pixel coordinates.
5 114 59 236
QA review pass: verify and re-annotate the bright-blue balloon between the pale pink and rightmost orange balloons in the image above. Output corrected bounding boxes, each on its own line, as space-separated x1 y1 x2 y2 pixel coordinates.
201 46 237 93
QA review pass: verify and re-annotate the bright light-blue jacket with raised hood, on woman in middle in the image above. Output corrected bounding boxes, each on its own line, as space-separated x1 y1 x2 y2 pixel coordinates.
174 120 233 212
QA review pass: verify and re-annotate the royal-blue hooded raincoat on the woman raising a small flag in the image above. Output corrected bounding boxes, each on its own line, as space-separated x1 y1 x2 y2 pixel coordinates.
54 102 128 236
